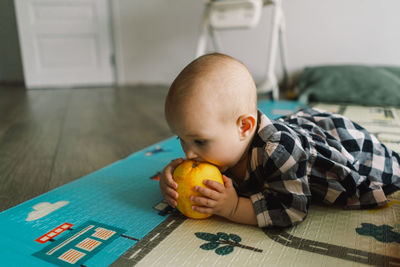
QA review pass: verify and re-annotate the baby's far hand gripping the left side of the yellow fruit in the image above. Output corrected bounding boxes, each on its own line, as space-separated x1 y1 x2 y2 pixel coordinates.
160 158 183 208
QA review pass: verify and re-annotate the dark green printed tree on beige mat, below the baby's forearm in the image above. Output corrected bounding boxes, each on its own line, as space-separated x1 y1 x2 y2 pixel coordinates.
195 232 262 256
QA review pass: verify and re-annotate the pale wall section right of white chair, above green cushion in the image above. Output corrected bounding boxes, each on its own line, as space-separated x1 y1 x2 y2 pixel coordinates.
285 0 400 75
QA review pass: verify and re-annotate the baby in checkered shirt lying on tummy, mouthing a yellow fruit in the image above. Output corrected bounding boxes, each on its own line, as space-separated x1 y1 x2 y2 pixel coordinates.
160 53 400 227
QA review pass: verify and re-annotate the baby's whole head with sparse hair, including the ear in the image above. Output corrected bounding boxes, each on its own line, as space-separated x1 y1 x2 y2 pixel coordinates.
165 53 257 171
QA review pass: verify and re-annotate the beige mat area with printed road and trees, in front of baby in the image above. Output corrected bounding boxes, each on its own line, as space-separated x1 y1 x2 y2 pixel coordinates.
112 192 400 266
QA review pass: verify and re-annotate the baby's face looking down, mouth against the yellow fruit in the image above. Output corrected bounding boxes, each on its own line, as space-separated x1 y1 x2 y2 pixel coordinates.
167 102 245 172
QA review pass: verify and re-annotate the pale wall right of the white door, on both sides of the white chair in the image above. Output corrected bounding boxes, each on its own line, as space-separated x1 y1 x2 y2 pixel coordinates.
115 0 400 84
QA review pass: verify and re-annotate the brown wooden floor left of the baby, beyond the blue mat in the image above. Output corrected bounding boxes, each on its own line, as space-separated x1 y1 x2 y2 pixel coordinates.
0 86 172 211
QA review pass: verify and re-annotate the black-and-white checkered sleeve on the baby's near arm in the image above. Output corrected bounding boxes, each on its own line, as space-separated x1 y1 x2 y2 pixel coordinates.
250 130 311 227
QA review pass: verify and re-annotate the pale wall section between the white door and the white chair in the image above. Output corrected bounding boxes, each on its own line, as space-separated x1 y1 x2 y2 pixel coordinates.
113 0 204 84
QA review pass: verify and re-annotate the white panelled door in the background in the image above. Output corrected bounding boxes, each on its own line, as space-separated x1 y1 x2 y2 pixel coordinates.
14 0 115 88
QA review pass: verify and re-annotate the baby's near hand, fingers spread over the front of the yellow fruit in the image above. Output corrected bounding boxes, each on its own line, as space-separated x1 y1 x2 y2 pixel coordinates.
191 175 239 219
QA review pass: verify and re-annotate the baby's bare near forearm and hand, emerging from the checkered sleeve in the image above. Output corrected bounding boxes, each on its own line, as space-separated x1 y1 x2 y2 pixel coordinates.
191 175 257 225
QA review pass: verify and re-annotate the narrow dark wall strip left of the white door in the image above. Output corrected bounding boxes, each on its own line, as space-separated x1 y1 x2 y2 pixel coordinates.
0 0 24 82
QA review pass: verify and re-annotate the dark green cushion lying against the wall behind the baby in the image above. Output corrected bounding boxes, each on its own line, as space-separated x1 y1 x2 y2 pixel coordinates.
298 65 400 106
